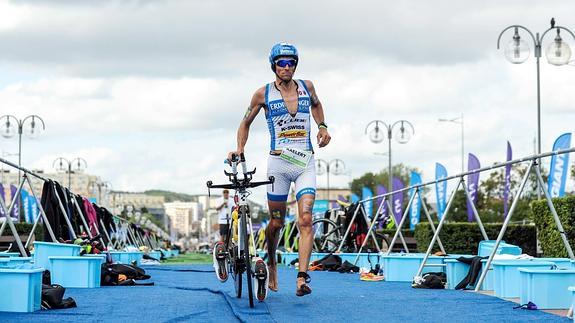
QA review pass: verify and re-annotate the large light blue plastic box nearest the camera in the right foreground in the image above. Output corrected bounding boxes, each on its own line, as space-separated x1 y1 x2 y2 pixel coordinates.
518 268 575 309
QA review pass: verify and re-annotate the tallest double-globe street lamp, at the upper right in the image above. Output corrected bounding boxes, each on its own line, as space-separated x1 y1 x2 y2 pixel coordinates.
497 19 575 158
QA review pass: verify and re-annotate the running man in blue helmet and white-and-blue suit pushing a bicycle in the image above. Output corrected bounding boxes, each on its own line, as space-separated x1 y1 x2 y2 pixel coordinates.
228 43 331 296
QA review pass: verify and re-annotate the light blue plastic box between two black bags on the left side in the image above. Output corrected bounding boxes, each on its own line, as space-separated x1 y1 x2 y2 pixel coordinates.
50 256 102 288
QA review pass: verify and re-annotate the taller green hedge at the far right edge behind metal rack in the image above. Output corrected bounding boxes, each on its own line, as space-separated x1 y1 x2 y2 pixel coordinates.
531 195 575 257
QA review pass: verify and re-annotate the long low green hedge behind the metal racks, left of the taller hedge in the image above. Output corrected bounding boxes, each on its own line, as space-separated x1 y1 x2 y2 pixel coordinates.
414 222 537 256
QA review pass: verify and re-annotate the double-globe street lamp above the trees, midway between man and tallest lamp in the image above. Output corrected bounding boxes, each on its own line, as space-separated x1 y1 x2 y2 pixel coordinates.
365 120 415 192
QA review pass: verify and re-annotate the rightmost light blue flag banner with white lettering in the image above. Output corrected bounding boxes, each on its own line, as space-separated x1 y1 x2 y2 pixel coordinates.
547 133 571 198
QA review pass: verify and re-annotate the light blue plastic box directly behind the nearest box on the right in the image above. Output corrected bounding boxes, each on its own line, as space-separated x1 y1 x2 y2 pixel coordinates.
492 259 555 298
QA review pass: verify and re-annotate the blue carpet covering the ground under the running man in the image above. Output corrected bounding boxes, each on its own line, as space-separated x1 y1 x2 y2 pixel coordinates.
0 265 569 323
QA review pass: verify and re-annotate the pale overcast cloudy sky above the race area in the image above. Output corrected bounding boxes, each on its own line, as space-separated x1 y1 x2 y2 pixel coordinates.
0 0 575 202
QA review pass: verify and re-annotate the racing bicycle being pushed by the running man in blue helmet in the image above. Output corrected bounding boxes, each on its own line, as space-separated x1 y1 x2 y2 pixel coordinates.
207 153 274 308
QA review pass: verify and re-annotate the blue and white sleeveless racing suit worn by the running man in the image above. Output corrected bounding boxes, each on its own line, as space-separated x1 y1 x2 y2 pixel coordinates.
265 80 316 202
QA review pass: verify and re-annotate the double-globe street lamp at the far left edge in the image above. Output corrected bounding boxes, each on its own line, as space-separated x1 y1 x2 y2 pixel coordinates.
0 114 46 178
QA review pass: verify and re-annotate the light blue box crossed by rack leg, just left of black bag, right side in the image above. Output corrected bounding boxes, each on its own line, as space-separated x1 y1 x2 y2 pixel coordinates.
381 253 445 282
